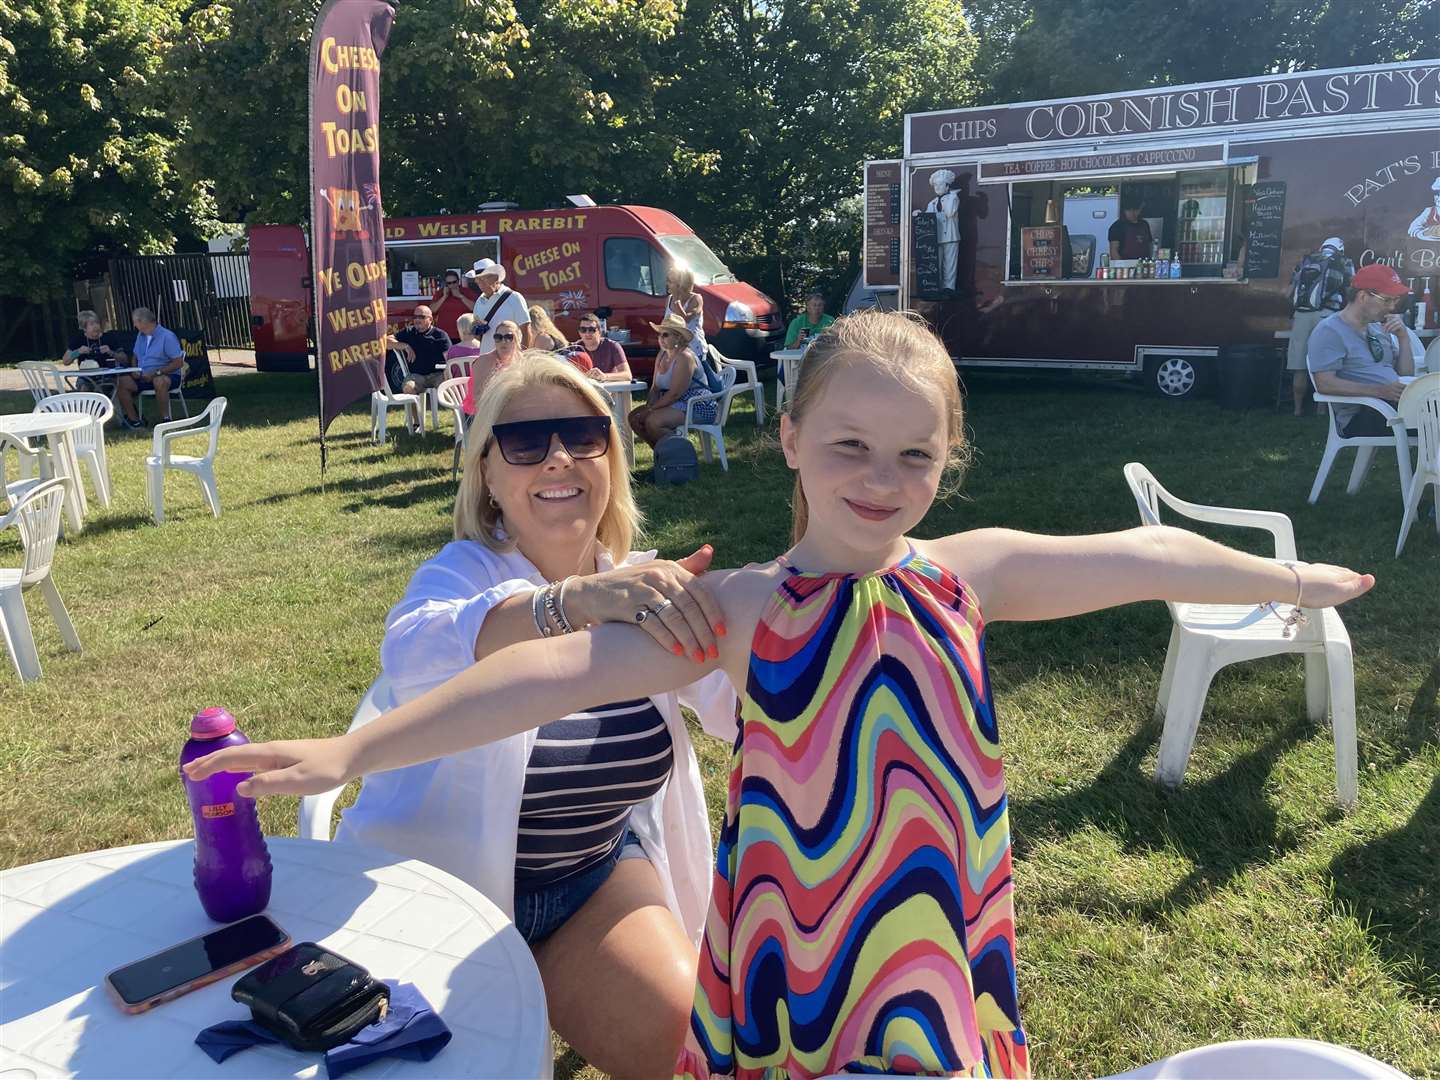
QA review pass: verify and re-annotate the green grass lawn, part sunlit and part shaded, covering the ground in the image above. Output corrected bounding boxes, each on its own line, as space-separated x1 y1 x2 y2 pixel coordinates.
0 374 1440 1077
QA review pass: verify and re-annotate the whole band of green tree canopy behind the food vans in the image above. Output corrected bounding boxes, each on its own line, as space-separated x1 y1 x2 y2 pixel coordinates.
0 0 1440 305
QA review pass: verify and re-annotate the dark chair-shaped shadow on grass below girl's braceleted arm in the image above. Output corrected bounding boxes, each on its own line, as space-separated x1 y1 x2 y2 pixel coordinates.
1011 719 1319 919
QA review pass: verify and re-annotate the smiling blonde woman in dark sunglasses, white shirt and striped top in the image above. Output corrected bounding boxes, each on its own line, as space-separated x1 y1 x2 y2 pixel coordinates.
337 352 736 1076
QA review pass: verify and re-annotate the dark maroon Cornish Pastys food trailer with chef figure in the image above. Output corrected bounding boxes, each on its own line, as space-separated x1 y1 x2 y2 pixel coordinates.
864 60 1440 397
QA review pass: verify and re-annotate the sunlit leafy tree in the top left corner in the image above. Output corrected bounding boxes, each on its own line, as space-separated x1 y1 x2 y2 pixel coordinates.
0 0 213 300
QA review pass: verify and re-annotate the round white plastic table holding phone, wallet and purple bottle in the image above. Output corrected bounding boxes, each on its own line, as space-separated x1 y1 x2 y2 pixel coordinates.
0 837 552 1080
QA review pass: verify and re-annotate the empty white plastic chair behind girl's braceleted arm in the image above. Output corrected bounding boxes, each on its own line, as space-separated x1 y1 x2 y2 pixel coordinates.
1125 461 1358 806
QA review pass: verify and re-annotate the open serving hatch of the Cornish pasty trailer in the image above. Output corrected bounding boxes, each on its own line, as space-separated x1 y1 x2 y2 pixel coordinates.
1008 166 1254 281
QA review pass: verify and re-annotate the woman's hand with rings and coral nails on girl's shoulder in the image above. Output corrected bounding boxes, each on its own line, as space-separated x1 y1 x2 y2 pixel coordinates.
564 544 726 664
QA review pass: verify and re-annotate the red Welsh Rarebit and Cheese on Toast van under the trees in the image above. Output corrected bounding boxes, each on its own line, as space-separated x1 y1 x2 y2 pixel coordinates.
249 204 783 377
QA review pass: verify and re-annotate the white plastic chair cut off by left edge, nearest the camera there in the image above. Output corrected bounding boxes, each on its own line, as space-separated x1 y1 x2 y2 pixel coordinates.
0 480 81 683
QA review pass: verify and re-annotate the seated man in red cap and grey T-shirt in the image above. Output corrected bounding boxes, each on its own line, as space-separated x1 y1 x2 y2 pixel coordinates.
1305 264 1416 438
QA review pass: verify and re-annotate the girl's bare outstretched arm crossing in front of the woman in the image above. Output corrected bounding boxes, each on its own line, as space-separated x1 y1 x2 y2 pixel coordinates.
184 622 734 796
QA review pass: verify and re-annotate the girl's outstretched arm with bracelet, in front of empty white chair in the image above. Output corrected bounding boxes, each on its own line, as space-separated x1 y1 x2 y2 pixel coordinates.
929 526 1375 622
